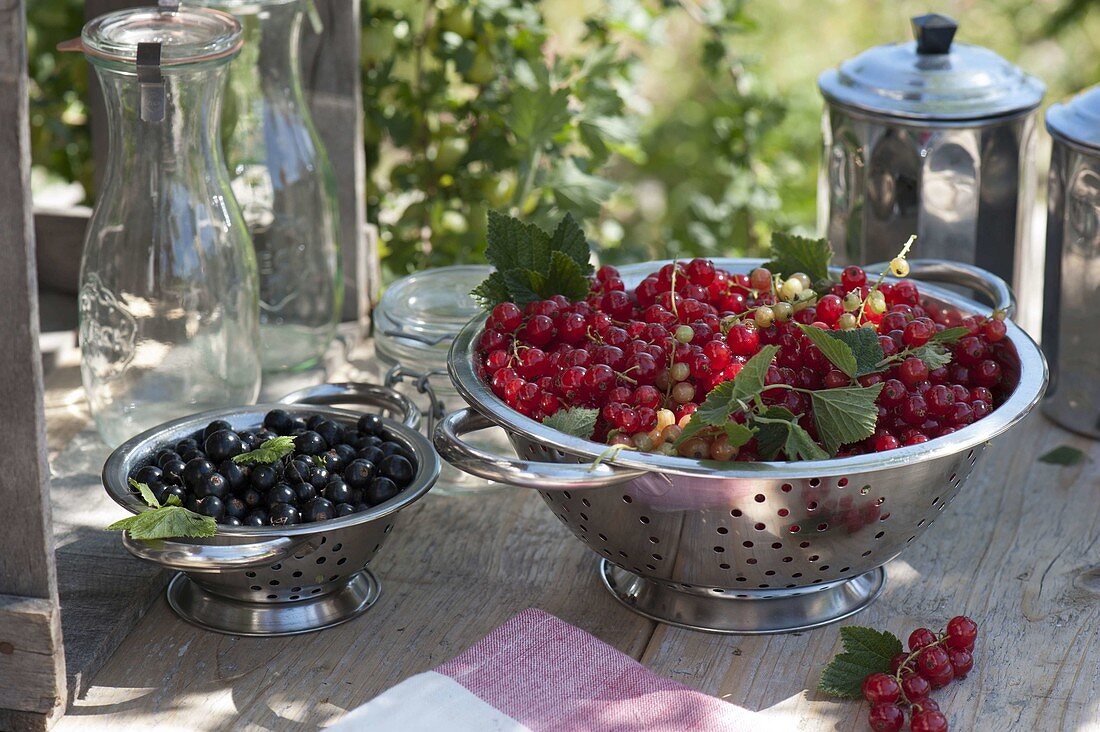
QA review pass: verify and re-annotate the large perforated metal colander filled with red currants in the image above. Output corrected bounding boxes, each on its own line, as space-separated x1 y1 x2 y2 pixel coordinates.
436 260 1047 633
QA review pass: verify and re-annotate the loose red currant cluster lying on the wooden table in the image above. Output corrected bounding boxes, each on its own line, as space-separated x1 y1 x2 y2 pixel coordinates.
862 615 978 732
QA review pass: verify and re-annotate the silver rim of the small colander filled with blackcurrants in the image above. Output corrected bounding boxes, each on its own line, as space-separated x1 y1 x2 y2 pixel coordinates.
102 404 440 534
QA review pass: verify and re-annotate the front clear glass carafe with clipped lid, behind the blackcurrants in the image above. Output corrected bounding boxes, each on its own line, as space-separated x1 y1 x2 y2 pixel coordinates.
79 8 261 445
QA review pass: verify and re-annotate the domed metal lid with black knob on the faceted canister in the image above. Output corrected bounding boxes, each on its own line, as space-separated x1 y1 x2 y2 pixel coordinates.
817 14 1045 121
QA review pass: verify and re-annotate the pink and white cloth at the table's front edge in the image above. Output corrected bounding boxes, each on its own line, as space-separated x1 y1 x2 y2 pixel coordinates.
329 609 770 732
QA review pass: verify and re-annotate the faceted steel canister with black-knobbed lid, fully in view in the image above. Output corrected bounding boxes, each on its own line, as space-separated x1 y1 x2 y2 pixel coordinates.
817 15 1044 290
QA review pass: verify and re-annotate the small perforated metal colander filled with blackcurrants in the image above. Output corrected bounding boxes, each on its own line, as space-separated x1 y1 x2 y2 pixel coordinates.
103 384 440 635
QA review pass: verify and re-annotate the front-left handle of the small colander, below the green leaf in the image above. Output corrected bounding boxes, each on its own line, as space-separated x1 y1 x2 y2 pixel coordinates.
122 532 319 572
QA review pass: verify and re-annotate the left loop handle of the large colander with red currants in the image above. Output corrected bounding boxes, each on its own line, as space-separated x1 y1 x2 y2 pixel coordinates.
435 408 646 491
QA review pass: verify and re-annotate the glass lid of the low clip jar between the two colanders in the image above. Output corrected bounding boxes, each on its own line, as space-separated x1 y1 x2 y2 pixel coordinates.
374 265 493 373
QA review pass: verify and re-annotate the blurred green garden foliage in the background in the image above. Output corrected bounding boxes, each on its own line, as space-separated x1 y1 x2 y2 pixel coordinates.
28 0 1100 277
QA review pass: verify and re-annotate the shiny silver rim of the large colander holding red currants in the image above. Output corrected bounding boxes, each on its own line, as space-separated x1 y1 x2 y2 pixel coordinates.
449 259 1047 479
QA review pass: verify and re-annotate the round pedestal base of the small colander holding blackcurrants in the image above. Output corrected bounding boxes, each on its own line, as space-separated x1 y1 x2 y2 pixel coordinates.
167 569 382 635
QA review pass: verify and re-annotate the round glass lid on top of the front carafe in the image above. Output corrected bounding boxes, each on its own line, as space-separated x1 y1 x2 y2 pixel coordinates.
80 6 242 66
